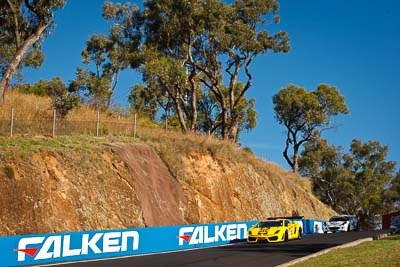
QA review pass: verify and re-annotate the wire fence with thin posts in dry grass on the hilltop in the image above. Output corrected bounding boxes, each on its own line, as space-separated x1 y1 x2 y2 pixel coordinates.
0 109 168 138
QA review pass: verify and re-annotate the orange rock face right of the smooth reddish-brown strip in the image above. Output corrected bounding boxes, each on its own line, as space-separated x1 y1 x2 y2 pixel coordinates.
182 153 333 223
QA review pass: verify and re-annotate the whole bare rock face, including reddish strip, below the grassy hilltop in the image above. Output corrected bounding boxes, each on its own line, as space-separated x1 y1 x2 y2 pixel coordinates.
0 140 333 235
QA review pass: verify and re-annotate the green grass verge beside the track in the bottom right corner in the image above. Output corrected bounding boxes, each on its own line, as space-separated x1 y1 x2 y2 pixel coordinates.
292 235 400 267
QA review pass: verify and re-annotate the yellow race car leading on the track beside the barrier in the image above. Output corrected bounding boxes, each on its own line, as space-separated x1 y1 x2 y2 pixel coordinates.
247 219 303 243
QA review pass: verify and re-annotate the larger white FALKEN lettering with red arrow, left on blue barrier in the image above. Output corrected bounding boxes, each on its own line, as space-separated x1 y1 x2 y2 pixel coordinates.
15 231 139 262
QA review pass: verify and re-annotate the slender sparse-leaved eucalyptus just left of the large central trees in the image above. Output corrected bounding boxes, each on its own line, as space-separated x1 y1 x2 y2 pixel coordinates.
71 2 142 110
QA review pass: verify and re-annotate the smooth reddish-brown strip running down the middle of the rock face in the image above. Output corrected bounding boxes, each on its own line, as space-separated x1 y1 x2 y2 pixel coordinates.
112 143 186 226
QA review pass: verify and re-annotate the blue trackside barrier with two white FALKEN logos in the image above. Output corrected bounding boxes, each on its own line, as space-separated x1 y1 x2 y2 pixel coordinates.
0 221 256 266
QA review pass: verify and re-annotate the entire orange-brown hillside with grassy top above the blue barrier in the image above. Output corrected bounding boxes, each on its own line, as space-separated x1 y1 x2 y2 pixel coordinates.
0 93 334 235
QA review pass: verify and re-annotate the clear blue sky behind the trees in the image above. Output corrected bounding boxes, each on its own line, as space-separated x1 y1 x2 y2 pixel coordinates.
24 0 400 172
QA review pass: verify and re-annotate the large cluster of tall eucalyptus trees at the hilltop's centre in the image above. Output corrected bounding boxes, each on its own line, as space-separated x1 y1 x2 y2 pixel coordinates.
107 0 290 140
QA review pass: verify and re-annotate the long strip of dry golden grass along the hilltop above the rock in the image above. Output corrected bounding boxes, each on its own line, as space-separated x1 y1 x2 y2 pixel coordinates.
0 91 300 184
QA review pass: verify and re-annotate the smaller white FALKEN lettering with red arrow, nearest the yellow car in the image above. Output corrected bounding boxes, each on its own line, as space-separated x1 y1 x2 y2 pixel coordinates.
177 224 247 246
